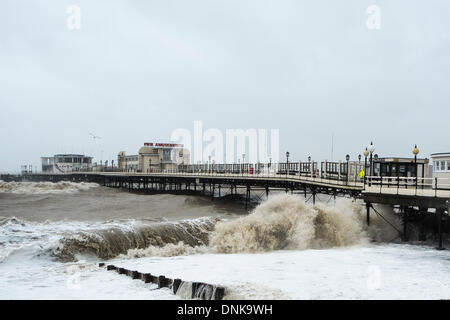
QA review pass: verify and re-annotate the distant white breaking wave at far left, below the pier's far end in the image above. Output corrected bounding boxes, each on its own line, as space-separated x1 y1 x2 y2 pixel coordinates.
0 181 99 194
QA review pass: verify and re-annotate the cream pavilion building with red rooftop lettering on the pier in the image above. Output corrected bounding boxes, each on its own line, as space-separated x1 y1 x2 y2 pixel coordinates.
117 142 190 173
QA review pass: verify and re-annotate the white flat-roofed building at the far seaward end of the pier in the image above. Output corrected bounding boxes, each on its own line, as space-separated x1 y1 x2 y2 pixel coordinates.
41 154 92 173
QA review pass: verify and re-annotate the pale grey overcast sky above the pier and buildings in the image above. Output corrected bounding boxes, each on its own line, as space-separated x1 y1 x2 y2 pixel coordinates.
0 0 450 172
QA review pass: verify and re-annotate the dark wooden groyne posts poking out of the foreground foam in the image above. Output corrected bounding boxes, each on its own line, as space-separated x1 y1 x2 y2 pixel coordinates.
99 263 226 300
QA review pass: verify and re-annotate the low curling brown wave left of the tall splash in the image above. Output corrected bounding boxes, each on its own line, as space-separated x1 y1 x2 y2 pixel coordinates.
53 218 217 261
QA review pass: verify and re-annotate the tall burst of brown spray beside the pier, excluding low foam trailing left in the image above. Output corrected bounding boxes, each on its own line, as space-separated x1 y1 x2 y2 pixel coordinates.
210 194 366 253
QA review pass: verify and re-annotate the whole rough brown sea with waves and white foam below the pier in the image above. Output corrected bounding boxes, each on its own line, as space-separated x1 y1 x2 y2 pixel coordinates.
0 181 450 299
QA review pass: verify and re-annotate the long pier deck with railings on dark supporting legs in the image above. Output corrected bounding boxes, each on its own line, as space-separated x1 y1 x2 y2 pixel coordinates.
0 162 450 249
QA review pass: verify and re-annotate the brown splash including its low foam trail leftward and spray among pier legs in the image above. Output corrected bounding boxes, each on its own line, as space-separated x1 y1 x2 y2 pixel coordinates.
120 194 401 258
